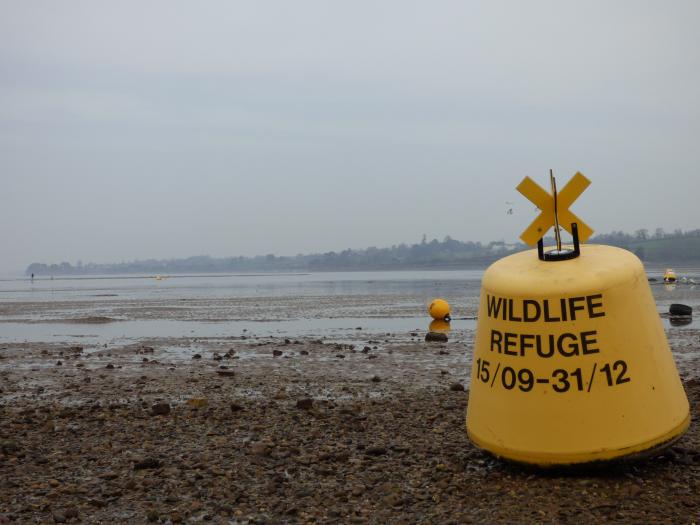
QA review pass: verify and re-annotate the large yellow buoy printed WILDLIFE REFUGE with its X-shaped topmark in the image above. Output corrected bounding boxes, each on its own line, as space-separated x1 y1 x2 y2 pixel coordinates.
467 170 690 466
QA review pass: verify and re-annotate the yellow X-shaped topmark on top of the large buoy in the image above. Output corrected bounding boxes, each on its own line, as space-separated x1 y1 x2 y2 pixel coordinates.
517 173 593 246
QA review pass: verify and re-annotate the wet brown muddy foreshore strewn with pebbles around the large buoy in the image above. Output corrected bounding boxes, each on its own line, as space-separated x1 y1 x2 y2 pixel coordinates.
0 327 700 524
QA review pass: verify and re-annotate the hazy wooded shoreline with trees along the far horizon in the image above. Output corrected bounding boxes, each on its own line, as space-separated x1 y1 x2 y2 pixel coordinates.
26 228 700 276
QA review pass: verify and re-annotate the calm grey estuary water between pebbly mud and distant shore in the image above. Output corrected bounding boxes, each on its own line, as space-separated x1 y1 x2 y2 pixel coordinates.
0 270 700 343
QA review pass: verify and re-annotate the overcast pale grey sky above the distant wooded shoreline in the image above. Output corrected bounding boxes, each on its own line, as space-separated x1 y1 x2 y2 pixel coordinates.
0 0 700 273
